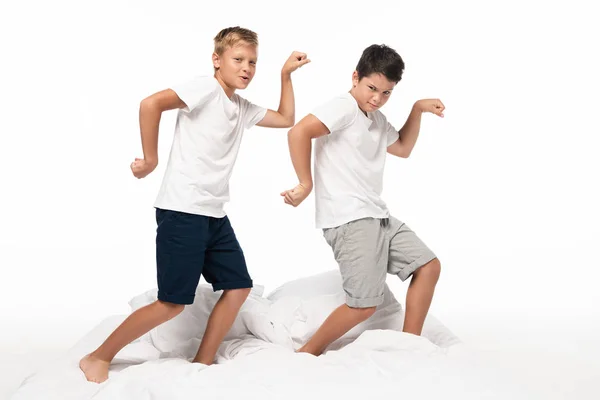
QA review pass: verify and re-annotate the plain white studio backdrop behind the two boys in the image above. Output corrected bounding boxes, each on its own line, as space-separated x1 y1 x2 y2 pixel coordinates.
0 1 600 398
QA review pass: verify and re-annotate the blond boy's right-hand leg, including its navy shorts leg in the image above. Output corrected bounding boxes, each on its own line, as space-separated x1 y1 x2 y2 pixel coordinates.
194 217 252 365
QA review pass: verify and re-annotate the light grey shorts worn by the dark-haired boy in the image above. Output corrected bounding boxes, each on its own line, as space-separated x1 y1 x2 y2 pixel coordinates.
323 217 436 308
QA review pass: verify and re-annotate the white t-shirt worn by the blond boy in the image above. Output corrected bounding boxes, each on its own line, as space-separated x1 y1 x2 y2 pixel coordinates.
154 76 267 218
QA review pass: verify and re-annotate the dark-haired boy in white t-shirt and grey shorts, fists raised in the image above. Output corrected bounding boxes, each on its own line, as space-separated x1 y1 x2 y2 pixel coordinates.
281 45 445 355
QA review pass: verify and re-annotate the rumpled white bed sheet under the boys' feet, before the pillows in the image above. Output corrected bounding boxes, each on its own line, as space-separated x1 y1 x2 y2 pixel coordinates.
7 316 537 400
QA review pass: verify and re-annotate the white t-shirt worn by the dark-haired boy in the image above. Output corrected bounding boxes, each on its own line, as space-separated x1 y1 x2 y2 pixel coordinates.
312 93 399 229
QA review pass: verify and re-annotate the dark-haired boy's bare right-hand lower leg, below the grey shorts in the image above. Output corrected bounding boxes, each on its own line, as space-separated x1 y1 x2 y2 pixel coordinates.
402 258 441 335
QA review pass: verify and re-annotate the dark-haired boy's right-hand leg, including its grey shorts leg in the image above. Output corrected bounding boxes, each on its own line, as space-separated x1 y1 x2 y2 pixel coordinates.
388 218 441 335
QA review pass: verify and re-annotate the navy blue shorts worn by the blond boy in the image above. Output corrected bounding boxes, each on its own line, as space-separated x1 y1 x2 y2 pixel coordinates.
156 208 252 304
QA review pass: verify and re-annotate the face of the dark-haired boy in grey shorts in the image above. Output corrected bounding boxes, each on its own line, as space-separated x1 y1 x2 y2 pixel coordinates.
352 71 396 112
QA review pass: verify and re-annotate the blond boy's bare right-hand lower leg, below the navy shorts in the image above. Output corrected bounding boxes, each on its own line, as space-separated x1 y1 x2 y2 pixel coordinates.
193 288 251 365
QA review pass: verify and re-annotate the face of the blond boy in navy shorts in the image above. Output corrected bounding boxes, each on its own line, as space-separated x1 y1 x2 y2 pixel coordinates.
213 41 258 89
